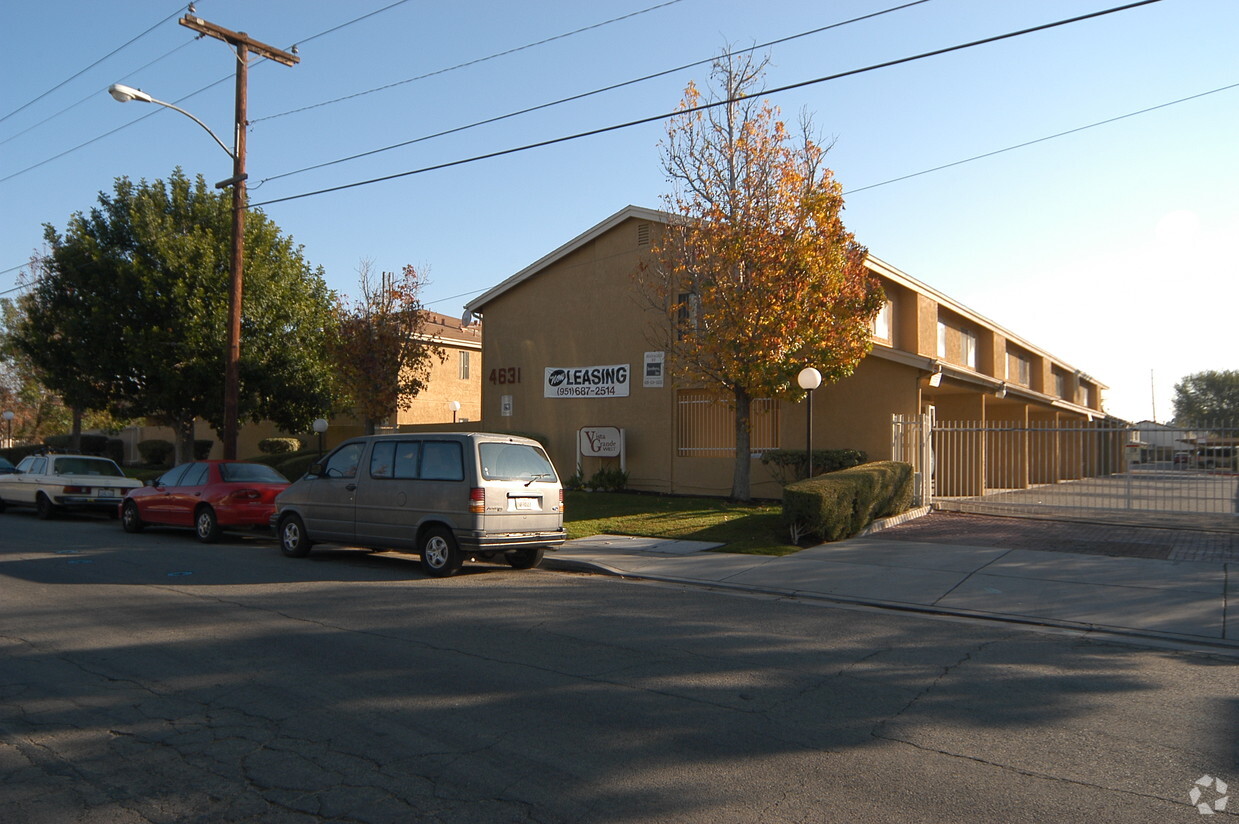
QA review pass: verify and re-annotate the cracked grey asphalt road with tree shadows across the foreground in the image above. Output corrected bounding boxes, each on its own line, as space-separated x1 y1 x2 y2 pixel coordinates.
0 512 1239 824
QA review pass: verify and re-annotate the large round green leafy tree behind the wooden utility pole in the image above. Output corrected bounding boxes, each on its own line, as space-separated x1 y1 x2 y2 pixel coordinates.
10 169 336 460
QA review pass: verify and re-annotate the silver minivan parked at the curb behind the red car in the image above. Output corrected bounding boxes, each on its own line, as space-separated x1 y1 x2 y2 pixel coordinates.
271 432 564 576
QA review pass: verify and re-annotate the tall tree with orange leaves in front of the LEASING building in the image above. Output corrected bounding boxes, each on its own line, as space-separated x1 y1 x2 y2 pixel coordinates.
637 55 885 501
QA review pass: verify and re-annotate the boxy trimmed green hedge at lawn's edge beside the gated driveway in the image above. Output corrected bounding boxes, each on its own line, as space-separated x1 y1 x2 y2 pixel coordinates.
783 461 912 543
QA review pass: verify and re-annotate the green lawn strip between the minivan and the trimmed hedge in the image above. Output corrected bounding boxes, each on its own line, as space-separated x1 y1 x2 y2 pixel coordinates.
564 492 800 555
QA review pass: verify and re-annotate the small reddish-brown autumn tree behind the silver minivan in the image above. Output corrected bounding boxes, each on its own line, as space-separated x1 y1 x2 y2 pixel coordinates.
335 260 447 435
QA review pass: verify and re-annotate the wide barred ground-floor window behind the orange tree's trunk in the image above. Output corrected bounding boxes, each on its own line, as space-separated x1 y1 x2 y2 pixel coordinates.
675 389 779 457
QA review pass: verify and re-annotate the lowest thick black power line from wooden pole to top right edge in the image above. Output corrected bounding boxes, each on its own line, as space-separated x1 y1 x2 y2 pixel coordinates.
250 0 1161 207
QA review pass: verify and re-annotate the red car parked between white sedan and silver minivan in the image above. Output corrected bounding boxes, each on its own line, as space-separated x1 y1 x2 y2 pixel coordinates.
120 461 289 544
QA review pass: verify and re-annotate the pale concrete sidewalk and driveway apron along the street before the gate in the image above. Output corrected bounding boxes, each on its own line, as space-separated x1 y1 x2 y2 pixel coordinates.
544 533 1239 654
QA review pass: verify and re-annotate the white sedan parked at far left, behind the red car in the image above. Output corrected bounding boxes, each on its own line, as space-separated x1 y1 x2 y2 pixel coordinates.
0 455 141 519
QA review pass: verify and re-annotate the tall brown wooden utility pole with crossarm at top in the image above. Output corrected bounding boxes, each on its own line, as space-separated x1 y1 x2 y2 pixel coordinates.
180 14 301 460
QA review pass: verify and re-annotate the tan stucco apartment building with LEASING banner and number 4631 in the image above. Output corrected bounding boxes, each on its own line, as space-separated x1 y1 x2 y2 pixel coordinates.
467 206 1105 498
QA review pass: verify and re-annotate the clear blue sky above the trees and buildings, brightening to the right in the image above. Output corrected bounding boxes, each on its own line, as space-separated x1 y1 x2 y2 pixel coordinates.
0 0 1239 420
